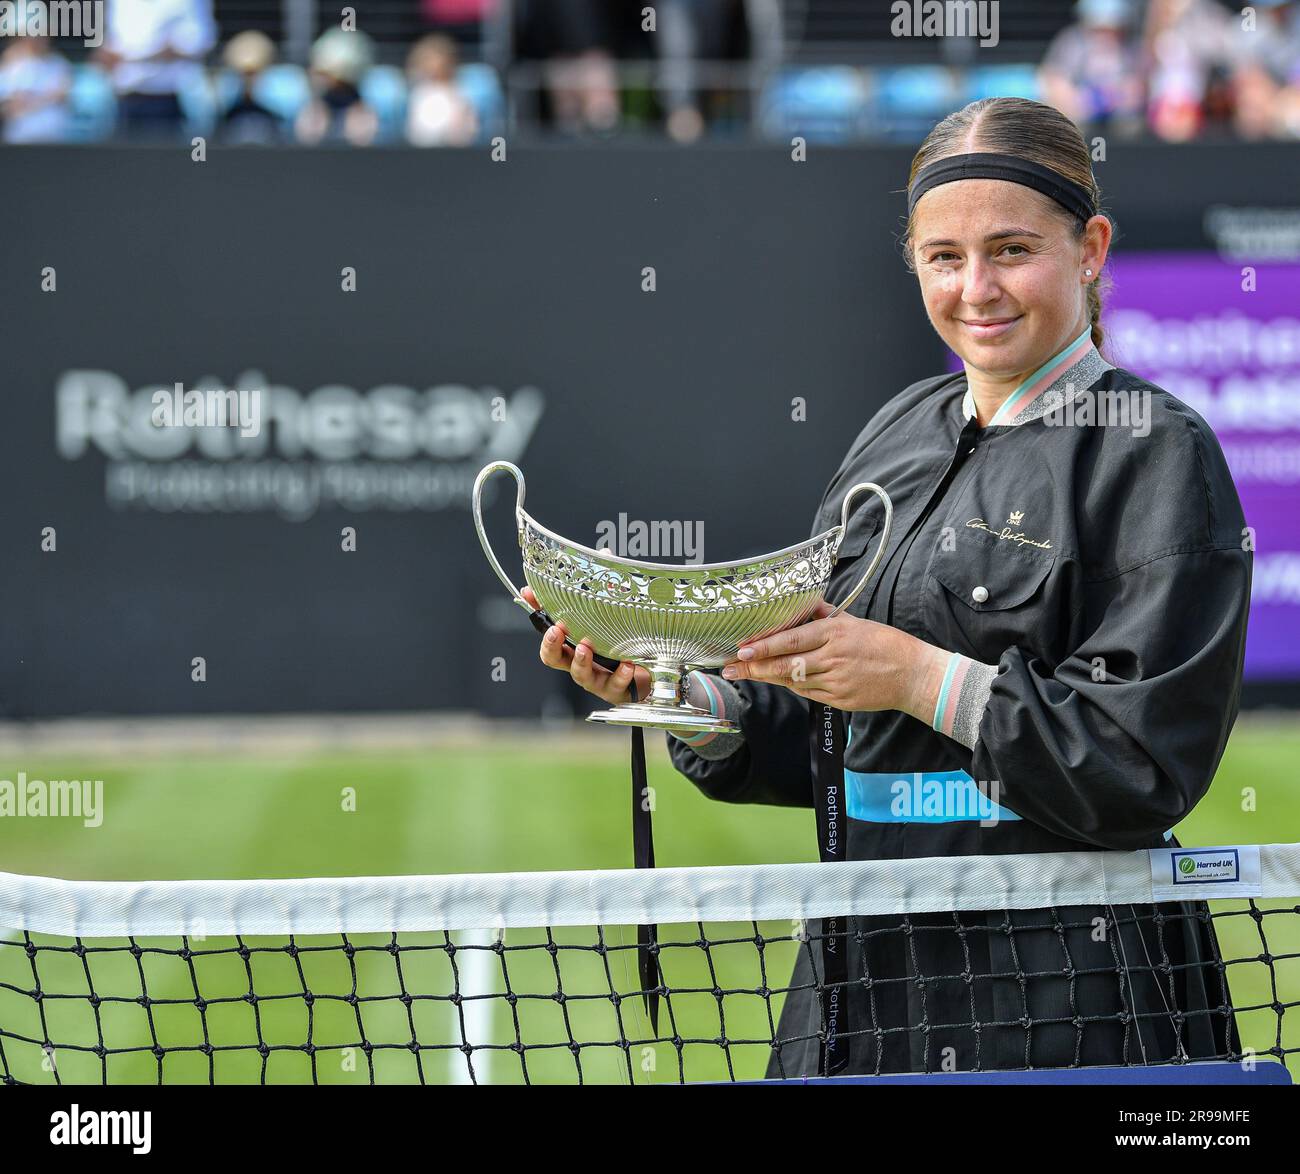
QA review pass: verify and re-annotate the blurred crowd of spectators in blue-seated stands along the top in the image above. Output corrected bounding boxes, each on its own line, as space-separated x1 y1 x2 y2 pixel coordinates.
0 0 1300 147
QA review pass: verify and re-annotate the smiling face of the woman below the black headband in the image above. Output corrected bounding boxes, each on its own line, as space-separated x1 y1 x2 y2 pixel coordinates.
911 179 1110 380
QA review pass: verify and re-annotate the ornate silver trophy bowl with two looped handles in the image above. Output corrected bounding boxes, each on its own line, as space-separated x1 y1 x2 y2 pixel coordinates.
473 460 893 733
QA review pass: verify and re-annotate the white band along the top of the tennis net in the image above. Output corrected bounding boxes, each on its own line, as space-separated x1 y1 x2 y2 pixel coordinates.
0 844 1300 937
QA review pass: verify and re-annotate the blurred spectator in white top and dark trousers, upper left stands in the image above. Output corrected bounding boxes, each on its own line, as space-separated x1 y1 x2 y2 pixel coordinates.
99 0 217 139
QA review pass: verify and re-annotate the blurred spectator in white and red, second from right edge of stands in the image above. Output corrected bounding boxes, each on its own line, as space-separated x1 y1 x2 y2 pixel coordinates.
1143 0 1232 143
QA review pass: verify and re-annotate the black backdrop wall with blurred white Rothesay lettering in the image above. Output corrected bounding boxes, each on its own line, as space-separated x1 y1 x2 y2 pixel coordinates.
0 146 1295 716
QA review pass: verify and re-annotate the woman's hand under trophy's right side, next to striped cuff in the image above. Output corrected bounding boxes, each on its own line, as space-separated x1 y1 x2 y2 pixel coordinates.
723 602 948 723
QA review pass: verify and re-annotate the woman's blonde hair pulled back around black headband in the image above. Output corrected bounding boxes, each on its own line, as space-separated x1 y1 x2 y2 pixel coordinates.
904 98 1108 350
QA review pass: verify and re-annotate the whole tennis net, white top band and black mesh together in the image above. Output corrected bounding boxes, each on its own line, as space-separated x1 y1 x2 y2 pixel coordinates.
0 845 1300 1084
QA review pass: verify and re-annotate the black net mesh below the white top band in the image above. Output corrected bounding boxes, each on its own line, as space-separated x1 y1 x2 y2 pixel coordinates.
0 900 1300 1084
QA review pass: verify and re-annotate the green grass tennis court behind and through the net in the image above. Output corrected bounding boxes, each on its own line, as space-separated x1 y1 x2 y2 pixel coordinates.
0 722 1300 1082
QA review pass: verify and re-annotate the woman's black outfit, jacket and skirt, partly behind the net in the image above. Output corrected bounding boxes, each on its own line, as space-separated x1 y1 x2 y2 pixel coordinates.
668 361 1252 1075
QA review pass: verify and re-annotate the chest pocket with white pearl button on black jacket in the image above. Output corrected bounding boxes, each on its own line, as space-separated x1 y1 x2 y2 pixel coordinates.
924 530 1063 664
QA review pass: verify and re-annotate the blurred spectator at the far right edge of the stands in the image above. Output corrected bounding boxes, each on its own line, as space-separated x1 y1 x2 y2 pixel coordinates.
1232 0 1300 139
